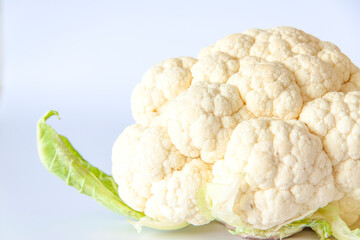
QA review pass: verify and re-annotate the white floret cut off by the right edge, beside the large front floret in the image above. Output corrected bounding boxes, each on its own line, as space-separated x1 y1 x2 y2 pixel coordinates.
299 91 360 172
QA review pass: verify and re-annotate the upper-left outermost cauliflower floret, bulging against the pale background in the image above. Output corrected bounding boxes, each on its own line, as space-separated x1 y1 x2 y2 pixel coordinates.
131 57 197 126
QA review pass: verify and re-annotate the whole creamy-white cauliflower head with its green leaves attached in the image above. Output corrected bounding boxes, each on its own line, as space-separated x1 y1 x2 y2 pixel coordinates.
38 27 360 239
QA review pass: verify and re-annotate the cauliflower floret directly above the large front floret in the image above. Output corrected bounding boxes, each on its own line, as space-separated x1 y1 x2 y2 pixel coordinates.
228 57 302 119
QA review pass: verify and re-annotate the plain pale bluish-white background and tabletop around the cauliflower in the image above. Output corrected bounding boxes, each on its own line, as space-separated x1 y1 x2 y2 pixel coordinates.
0 0 360 240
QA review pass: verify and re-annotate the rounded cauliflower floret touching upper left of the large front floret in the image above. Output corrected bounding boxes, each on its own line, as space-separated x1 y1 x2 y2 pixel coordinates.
167 82 248 163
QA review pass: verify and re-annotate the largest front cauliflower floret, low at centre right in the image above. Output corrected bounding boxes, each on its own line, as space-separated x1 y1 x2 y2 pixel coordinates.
213 118 337 230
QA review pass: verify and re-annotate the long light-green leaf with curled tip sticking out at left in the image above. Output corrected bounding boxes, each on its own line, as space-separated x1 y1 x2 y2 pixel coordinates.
37 110 145 220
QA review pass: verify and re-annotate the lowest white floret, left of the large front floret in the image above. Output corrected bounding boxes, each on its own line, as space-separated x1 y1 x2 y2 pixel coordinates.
144 159 211 225
